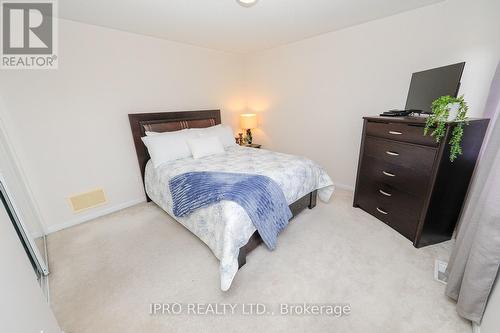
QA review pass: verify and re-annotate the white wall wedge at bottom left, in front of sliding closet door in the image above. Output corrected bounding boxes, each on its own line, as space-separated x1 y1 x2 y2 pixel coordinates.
0 203 61 333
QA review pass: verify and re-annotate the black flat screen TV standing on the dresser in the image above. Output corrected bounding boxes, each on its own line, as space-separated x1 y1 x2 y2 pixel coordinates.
405 62 465 113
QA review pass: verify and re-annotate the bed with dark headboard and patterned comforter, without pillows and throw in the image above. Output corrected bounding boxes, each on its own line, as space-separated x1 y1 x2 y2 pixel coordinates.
129 110 333 291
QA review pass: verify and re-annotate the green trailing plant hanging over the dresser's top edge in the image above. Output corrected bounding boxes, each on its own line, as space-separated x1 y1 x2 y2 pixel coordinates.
424 95 469 162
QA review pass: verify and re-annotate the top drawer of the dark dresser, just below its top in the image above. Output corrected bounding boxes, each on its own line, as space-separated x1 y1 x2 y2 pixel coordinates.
366 121 438 147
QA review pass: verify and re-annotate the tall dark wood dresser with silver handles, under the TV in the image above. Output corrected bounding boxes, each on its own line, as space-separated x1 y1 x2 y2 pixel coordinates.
354 117 489 247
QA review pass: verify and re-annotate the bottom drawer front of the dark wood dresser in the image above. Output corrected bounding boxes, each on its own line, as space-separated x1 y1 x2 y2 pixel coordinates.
357 180 424 240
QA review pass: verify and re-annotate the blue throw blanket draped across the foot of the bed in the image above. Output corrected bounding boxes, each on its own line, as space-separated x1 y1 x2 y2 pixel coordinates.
170 172 292 250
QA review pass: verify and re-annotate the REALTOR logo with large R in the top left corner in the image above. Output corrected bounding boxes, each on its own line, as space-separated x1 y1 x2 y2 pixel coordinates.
0 0 58 69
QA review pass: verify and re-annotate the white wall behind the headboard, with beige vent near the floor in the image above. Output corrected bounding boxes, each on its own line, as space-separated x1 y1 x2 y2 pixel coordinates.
0 20 244 231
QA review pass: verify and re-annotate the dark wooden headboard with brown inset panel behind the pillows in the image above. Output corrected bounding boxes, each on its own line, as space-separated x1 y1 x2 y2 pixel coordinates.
128 110 221 196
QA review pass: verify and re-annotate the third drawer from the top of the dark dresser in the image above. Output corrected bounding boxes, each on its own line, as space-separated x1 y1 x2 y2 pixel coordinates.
359 156 431 197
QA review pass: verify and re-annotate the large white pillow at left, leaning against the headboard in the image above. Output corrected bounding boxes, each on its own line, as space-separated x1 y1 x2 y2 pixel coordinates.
142 130 193 168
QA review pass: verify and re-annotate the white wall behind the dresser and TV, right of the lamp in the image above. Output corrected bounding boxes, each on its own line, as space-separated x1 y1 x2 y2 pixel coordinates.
246 0 500 186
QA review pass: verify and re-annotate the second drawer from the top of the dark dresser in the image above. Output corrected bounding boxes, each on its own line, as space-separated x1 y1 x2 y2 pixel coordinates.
364 137 437 174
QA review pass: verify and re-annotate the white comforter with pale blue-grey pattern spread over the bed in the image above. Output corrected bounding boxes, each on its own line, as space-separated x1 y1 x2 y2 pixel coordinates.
145 146 333 290
